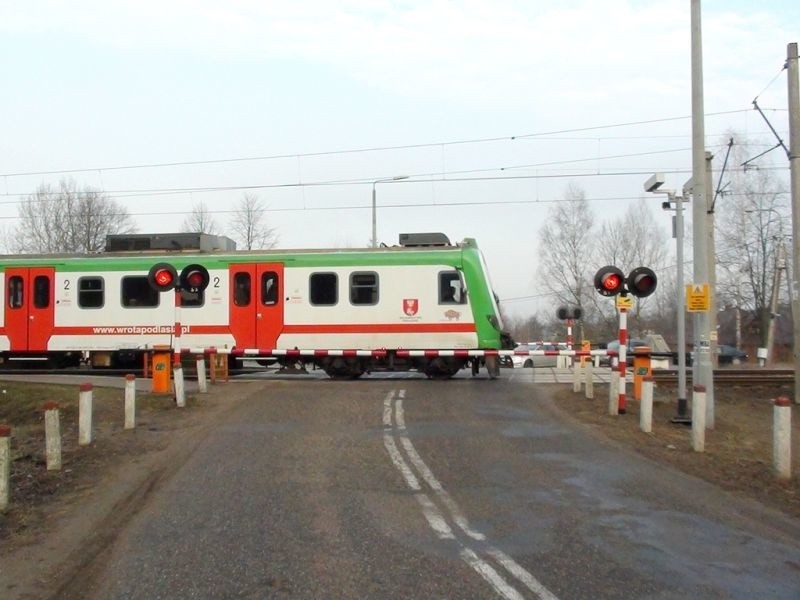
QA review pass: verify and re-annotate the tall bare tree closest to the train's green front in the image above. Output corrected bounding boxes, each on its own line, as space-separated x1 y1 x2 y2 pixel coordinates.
539 183 594 336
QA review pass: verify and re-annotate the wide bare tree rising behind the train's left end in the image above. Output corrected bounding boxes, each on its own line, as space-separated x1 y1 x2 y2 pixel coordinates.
12 179 136 253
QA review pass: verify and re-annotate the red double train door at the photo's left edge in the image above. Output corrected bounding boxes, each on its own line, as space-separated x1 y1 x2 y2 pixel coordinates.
4 267 55 352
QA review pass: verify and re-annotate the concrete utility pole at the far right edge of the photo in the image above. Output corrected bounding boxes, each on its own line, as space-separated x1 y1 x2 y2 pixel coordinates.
786 42 800 404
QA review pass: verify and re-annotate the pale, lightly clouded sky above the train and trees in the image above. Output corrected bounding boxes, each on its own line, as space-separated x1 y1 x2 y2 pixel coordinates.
0 0 800 317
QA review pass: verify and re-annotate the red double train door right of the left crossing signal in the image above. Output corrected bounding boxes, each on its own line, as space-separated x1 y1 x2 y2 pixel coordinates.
229 263 284 349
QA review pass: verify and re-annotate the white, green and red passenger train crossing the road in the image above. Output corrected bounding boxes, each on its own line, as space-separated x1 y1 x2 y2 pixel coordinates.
0 233 514 378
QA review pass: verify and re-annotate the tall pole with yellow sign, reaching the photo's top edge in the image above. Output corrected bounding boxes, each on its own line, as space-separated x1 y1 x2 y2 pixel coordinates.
691 0 714 429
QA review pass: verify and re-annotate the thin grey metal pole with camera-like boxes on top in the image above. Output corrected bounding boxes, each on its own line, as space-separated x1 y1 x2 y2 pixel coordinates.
644 173 692 423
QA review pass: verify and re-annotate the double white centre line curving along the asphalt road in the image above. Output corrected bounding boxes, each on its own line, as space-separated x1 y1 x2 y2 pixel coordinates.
383 389 558 600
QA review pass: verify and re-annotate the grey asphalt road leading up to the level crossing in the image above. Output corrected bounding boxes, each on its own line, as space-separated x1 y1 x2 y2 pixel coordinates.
72 377 800 599
